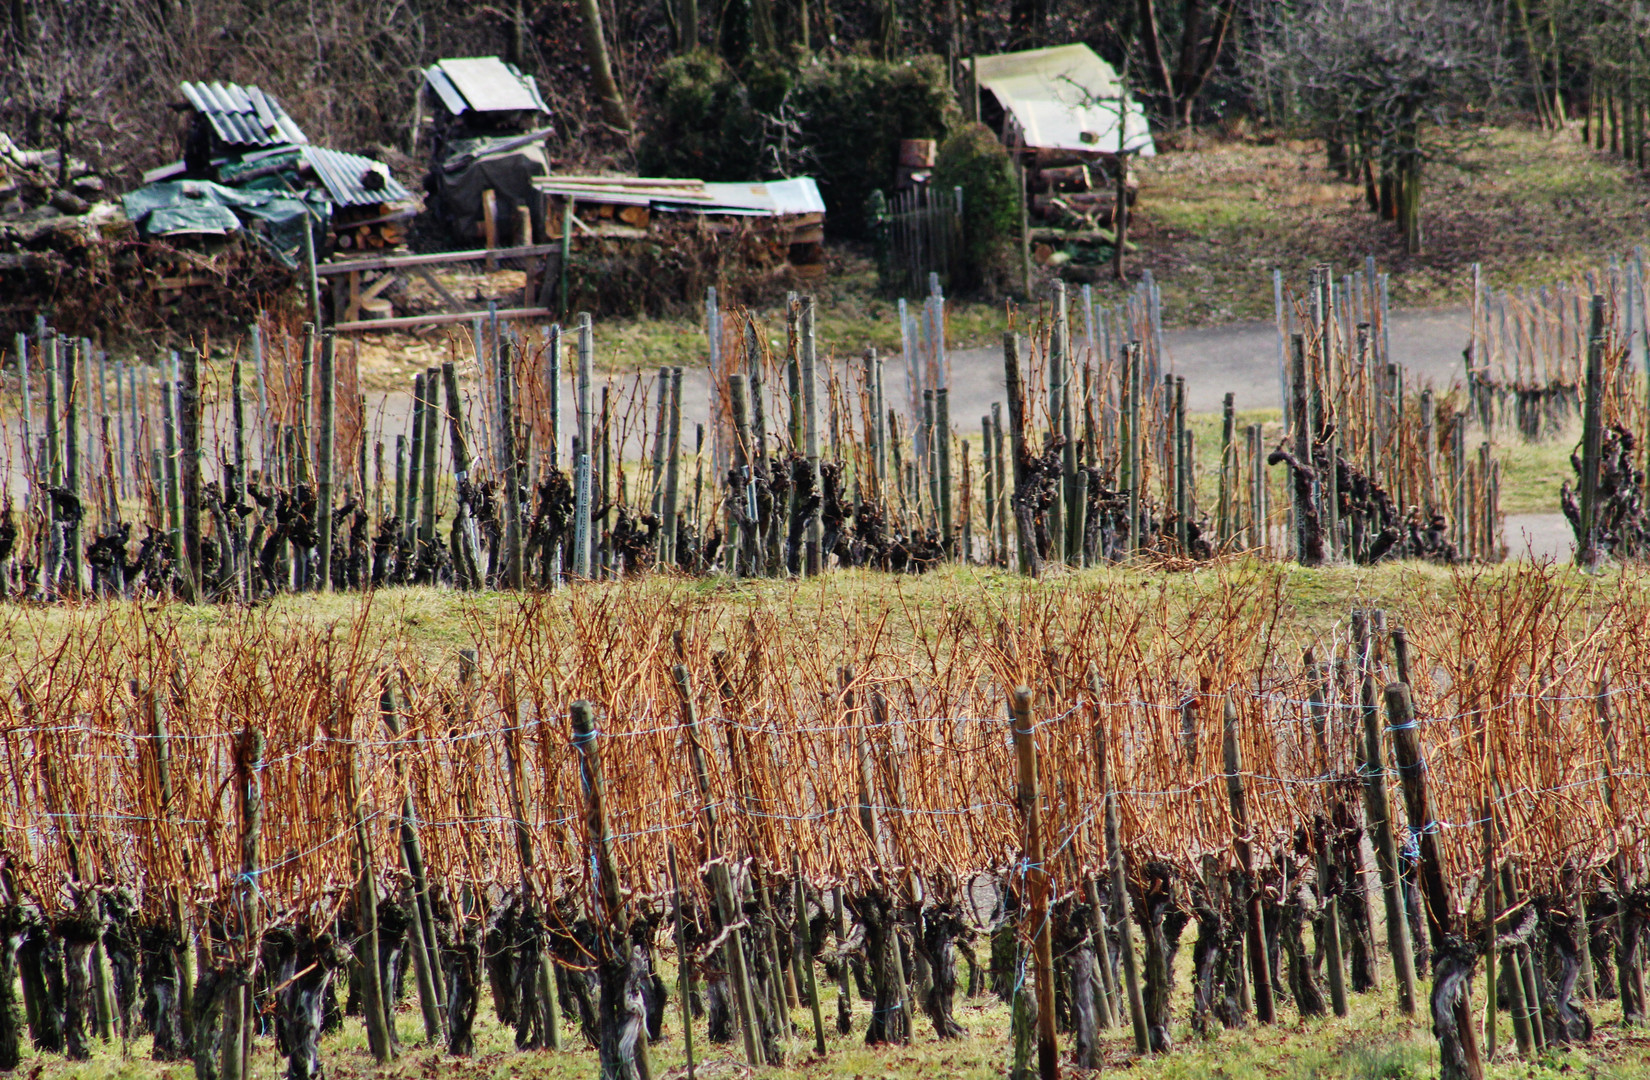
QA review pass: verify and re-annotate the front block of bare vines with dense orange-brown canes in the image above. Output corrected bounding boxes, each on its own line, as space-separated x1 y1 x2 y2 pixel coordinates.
0 564 1650 1077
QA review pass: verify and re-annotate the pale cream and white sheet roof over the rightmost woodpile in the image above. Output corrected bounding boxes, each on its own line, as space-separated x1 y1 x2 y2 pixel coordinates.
974 45 1157 157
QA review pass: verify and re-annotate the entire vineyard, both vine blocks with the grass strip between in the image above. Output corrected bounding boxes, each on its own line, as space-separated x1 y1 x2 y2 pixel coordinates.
0 257 1650 1080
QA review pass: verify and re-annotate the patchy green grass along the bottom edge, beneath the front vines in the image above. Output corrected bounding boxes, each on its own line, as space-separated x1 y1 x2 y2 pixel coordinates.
21 949 1650 1080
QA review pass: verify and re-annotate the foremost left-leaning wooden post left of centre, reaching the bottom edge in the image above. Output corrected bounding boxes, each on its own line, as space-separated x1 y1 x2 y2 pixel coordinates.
569 701 653 1080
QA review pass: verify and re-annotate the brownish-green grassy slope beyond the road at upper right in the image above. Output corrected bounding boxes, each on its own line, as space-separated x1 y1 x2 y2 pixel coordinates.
1082 127 1650 326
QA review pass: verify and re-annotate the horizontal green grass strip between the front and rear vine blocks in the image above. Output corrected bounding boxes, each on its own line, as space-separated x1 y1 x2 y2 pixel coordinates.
0 556 1630 671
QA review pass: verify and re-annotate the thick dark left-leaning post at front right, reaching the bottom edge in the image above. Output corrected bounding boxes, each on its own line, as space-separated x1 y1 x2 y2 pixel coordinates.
1386 683 1493 1080
